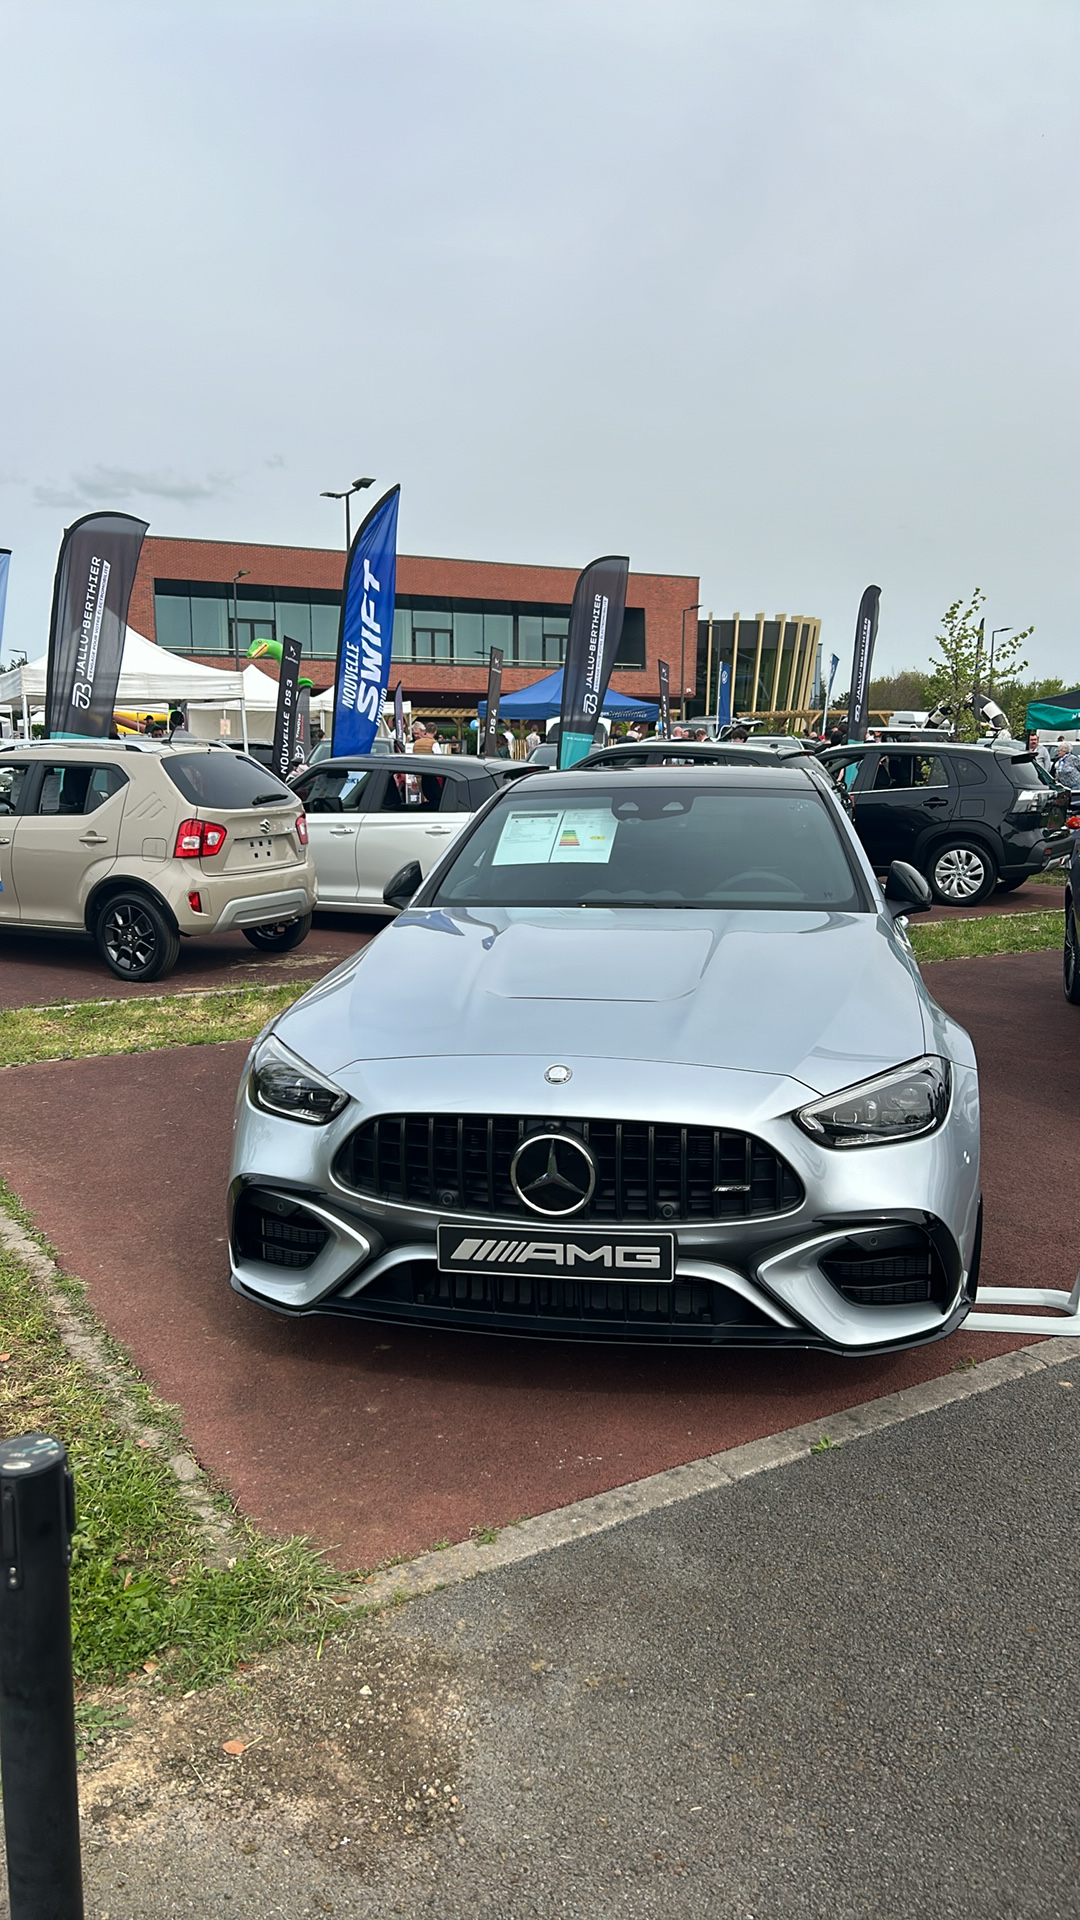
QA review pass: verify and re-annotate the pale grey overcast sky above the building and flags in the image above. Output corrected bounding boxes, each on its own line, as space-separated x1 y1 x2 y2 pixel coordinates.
0 0 1080 685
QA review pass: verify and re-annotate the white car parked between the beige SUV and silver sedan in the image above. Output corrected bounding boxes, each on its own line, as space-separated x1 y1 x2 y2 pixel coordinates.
290 753 511 916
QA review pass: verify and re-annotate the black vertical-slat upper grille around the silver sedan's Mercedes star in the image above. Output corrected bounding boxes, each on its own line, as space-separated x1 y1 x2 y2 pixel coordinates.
334 1114 803 1225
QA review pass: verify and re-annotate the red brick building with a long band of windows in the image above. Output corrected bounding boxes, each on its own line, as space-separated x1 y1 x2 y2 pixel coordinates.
129 538 700 714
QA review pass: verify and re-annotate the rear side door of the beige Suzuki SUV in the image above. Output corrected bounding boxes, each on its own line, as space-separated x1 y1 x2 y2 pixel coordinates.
12 756 129 927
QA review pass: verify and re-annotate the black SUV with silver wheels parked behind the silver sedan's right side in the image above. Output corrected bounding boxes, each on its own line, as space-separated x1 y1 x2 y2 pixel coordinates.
821 741 1068 906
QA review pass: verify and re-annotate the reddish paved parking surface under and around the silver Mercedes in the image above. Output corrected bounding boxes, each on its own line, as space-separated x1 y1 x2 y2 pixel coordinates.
0 954 1060 1567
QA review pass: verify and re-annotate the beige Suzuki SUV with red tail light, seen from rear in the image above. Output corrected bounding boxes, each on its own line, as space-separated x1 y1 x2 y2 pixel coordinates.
0 739 315 979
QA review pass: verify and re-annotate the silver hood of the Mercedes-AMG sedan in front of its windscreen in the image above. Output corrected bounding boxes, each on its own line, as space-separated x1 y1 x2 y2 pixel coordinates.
275 908 942 1092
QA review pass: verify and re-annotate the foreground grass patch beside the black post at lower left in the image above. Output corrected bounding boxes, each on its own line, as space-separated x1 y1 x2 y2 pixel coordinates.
0 1192 354 1688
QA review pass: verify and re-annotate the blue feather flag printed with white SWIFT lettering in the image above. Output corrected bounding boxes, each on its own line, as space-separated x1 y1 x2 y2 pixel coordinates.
331 486 402 753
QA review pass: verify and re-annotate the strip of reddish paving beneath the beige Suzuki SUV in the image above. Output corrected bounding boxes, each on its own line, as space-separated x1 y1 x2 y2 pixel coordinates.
0 914 380 1008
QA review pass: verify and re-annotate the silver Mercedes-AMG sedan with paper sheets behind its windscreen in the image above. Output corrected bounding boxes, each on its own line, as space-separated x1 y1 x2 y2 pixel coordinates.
229 764 980 1354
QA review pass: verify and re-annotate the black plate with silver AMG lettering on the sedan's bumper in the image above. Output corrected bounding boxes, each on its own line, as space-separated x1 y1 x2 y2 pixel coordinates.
438 1227 675 1284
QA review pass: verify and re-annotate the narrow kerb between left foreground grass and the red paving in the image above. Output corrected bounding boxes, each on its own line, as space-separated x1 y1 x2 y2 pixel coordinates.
0 1210 238 1567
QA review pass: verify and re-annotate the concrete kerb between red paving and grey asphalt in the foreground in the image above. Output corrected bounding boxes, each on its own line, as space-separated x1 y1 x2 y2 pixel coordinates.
359 1338 1080 1607
